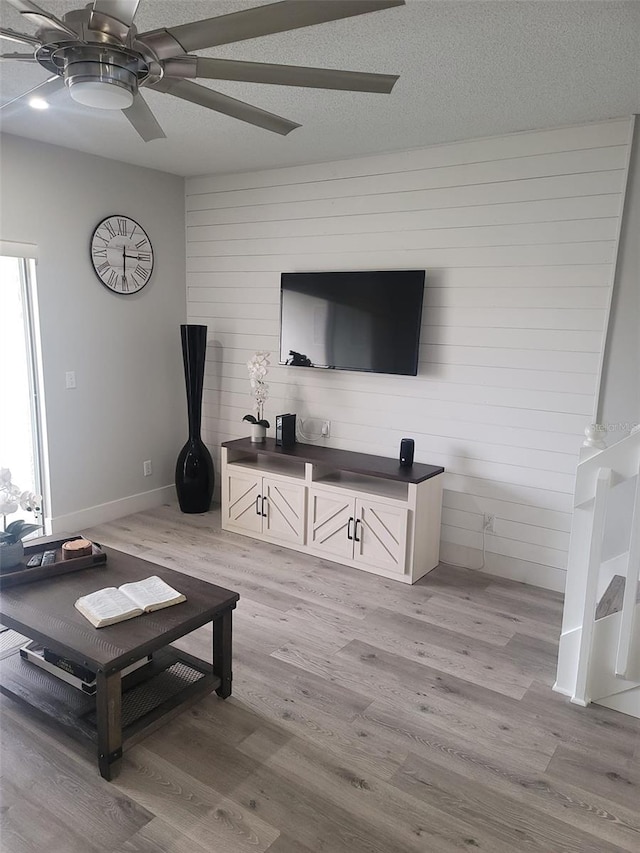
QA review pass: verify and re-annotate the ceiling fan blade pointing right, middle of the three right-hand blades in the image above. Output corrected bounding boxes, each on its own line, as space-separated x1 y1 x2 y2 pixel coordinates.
180 56 398 94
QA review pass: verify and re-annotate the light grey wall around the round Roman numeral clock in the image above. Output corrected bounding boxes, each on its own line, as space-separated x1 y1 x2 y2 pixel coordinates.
0 135 187 532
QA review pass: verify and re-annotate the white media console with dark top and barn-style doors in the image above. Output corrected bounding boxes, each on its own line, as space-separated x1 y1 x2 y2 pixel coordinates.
222 438 444 583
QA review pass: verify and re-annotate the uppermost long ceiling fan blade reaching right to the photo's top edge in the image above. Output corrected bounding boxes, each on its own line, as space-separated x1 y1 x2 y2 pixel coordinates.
139 0 405 59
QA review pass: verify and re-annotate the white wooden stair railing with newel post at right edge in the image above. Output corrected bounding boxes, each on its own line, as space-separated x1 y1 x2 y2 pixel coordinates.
554 431 640 705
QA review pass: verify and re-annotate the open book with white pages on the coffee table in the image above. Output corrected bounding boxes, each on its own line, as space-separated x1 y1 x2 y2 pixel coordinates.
75 575 187 628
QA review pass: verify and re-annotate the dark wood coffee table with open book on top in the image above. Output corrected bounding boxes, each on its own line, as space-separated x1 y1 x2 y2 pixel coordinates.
0 548 240 780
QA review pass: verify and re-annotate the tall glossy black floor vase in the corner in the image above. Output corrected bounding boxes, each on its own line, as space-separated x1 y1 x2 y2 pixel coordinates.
176 325 215 512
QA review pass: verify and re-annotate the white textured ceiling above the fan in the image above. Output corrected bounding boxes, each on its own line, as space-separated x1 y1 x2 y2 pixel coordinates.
0 0 640 175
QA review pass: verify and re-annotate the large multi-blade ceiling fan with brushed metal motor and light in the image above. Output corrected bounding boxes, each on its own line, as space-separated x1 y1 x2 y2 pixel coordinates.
0 0 405 142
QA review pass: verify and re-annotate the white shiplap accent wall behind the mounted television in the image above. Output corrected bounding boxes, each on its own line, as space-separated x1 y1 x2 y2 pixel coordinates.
186 120 630 589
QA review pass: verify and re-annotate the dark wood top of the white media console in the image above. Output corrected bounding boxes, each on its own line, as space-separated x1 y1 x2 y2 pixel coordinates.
222 438 444 483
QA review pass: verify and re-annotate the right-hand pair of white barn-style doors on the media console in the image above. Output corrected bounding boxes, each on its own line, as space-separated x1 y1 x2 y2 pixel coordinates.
308 489 408 574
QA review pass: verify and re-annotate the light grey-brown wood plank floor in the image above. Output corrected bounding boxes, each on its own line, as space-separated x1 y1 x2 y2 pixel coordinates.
0 506 640 853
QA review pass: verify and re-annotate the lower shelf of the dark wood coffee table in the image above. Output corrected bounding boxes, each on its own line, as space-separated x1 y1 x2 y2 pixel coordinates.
0 646 221 746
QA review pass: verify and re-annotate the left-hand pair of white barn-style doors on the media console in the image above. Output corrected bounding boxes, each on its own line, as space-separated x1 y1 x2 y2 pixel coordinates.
222 469 305 544
